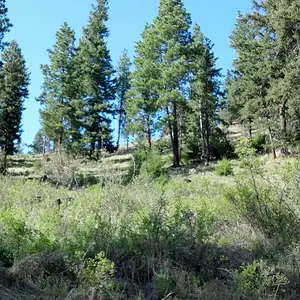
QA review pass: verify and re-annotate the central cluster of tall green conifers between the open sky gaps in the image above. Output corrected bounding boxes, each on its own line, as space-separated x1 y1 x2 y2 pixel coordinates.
34 0 222 166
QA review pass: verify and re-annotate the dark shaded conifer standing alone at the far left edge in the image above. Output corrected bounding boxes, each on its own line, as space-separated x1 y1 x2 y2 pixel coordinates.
0 41 29 155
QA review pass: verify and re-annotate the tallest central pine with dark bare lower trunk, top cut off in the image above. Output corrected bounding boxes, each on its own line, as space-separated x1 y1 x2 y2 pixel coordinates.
154 0 191 167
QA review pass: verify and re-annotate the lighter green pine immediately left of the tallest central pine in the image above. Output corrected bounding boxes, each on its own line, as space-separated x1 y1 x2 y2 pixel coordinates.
125 25 160 148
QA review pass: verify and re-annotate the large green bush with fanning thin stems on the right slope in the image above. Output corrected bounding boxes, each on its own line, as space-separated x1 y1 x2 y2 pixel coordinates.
226 160 300 245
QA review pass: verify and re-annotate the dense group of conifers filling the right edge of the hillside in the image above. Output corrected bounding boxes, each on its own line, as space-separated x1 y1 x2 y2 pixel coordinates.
222 0 300 158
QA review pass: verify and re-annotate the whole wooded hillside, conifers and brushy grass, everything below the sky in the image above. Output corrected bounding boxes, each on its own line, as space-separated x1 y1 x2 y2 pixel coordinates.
0 0 300 300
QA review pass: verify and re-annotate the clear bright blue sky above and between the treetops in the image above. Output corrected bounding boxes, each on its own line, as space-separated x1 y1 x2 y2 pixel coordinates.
6 0 251 148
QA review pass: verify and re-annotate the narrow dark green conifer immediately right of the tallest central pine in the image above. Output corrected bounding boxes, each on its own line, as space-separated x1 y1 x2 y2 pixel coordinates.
188 25 221 164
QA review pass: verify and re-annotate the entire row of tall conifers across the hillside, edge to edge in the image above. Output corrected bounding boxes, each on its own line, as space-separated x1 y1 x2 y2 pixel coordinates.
0 0 300 166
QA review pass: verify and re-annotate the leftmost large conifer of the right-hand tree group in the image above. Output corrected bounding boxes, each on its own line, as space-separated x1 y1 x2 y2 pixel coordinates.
228 5 280 157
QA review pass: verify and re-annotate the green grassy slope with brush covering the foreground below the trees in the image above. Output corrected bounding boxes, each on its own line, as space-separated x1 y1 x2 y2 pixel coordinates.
0 154 300 300
